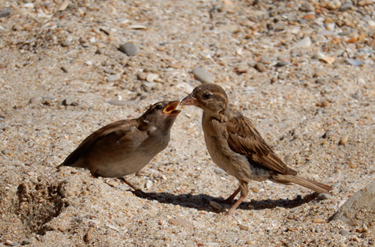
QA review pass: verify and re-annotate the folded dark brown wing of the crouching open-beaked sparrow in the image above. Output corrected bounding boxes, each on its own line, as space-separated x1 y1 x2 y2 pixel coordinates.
60 120 137 166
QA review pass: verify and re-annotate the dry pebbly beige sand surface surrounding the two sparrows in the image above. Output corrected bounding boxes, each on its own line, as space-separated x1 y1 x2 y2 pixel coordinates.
0 0 375 246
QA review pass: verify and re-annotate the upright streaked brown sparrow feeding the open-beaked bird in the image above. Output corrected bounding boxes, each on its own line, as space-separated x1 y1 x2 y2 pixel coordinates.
181 83 332 215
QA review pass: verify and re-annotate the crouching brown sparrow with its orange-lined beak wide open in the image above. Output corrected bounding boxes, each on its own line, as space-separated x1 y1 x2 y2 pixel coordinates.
57 100 180 190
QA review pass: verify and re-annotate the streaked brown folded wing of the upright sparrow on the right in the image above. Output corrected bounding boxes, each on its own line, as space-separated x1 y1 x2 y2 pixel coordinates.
227 116 296 174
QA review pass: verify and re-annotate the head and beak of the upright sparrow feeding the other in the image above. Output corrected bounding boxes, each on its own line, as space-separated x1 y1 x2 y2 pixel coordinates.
181 83 228 118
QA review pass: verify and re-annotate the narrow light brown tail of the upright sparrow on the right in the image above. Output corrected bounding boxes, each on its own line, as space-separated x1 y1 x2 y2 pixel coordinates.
272 174 332 193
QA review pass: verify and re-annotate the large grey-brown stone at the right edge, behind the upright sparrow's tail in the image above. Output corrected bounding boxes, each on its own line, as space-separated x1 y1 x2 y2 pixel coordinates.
332 181 375 229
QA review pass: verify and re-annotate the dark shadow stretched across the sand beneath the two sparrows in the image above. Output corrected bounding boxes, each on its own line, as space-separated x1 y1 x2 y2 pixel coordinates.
133 191 318 212
